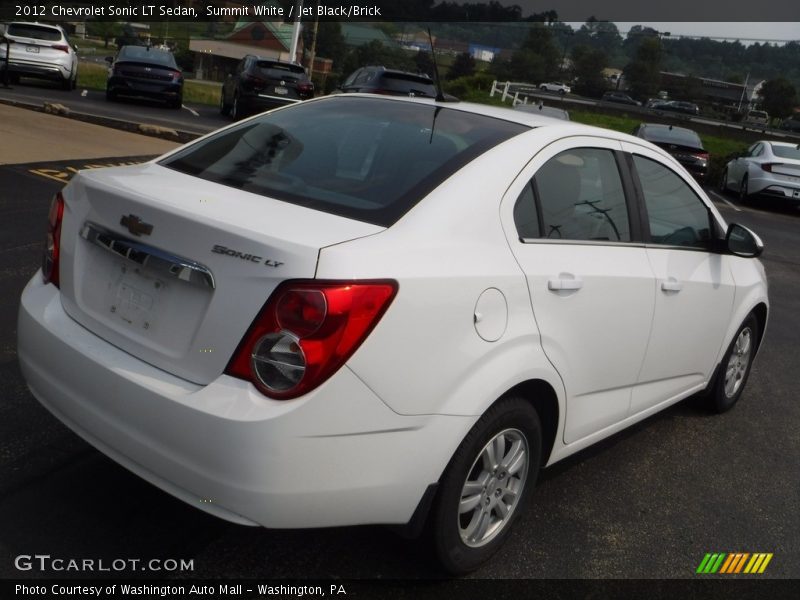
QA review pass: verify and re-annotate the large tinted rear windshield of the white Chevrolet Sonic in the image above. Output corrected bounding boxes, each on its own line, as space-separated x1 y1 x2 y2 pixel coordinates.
160 96 529 227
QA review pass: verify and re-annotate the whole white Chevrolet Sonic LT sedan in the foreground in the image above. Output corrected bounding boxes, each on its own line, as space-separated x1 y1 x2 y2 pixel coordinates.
18 94 768 573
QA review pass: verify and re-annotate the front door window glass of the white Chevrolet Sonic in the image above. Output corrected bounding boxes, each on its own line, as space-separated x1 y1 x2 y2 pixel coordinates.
633 156 711 248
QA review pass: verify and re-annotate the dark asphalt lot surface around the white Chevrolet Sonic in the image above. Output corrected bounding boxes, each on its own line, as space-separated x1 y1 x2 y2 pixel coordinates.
0 109 800 580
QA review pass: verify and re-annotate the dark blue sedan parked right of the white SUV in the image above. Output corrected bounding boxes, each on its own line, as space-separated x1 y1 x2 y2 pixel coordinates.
106 46 183 108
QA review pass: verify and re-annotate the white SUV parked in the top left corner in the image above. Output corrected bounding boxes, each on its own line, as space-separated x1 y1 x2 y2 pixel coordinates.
0 22 78 90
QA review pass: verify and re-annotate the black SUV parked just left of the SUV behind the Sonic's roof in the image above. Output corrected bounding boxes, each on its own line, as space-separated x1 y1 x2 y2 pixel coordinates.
219 55 314 120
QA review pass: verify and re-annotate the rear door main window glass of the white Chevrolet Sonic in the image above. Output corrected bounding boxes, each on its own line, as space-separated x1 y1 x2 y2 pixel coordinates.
534 148 631 242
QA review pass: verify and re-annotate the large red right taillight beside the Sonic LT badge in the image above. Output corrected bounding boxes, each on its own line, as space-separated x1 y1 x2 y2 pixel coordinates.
225 280 397 400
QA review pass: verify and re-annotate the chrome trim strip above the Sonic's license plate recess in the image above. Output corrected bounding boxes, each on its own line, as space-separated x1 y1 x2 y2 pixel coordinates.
81 221 216 290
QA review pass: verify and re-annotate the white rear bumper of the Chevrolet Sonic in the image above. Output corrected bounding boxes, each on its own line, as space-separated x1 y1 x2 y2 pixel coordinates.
18 273 474 528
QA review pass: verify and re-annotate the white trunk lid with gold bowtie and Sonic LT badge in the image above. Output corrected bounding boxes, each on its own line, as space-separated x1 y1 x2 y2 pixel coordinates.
60 163 383 384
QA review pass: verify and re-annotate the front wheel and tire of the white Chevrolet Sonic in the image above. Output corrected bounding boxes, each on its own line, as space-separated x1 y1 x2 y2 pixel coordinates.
706 314 760 413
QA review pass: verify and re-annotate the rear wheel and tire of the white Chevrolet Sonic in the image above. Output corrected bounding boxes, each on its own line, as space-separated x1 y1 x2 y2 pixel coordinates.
428 397 542 575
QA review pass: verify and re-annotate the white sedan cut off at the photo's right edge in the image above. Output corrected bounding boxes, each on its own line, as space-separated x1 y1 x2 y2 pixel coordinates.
720 140 800 201
